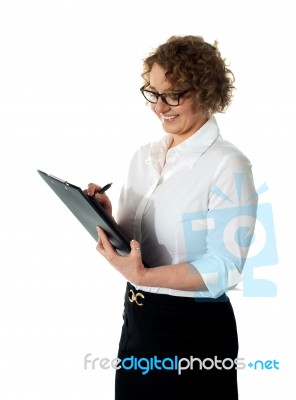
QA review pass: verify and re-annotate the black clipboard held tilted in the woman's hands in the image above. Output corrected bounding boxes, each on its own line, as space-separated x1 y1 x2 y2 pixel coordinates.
37 170 131 255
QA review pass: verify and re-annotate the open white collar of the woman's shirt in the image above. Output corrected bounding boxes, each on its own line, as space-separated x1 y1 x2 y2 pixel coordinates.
146 117 220 170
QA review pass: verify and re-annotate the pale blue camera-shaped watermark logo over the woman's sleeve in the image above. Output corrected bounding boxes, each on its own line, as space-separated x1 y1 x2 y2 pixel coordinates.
182 173 278 297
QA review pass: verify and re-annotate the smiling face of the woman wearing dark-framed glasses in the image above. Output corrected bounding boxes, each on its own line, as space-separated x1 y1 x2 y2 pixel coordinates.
149 63 207 147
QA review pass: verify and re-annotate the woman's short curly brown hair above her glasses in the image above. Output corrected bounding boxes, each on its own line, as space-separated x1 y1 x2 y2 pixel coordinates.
141 36 234 115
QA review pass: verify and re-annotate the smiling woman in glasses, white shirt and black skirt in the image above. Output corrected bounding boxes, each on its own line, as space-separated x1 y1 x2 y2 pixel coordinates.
88 36 257 400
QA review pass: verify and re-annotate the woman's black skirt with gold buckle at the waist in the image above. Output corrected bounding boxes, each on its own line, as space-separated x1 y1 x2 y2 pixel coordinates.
115 283 238 400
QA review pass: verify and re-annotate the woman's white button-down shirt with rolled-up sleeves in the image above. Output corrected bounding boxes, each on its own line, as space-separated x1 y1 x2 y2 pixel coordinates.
117 117 257 298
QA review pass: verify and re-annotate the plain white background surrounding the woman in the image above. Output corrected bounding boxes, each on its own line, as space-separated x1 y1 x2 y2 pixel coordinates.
0 0 295 400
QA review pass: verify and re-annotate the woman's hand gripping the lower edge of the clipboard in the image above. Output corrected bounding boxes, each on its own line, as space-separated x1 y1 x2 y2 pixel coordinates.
97 227 146 285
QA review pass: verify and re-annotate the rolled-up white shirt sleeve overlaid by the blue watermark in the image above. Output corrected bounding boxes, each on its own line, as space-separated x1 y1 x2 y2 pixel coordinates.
188 155 257 297
